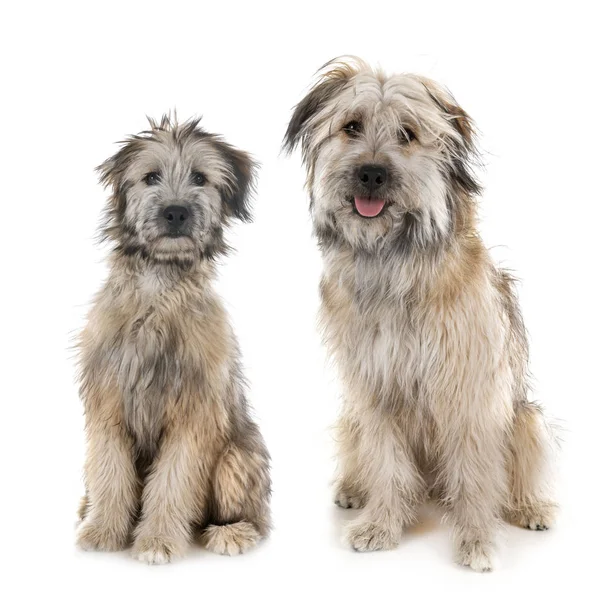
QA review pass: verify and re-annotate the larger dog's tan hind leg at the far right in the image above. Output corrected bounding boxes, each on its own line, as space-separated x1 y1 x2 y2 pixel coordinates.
504 402 558 531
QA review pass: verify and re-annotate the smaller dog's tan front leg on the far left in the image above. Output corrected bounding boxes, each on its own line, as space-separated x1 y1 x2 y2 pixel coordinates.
77 404 140 551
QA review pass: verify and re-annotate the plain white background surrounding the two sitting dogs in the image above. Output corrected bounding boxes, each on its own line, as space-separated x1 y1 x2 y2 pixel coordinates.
0 0 600 593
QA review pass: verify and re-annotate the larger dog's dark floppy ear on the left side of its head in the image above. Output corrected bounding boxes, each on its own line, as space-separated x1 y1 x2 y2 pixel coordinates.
283 64 353 154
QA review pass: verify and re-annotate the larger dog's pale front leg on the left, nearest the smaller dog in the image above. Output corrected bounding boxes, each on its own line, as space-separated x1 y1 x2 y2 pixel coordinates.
347 410 425 552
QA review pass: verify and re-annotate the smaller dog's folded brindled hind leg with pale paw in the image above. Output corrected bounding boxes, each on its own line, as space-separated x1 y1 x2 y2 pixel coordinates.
200 424 271 556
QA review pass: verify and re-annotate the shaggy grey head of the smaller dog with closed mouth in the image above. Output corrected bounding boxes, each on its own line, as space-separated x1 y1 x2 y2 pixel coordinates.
99 117 254 265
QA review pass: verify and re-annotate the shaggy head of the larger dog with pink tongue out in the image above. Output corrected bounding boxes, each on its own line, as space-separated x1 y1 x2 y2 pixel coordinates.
285 61 478 251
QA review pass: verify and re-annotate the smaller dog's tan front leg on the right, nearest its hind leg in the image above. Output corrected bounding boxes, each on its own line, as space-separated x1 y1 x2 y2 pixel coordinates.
133 426 212 564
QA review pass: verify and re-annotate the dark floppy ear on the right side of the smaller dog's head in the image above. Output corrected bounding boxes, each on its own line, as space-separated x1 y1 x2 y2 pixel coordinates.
218 141 258 221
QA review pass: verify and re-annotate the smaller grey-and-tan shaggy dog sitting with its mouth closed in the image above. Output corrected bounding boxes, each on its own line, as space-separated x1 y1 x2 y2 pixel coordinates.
77 117 270 564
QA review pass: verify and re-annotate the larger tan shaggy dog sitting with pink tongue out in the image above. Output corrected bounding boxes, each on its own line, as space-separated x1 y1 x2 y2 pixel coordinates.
285 59 555 571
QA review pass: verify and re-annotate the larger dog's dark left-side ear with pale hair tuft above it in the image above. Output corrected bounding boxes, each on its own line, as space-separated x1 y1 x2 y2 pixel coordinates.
282 56 369 155
